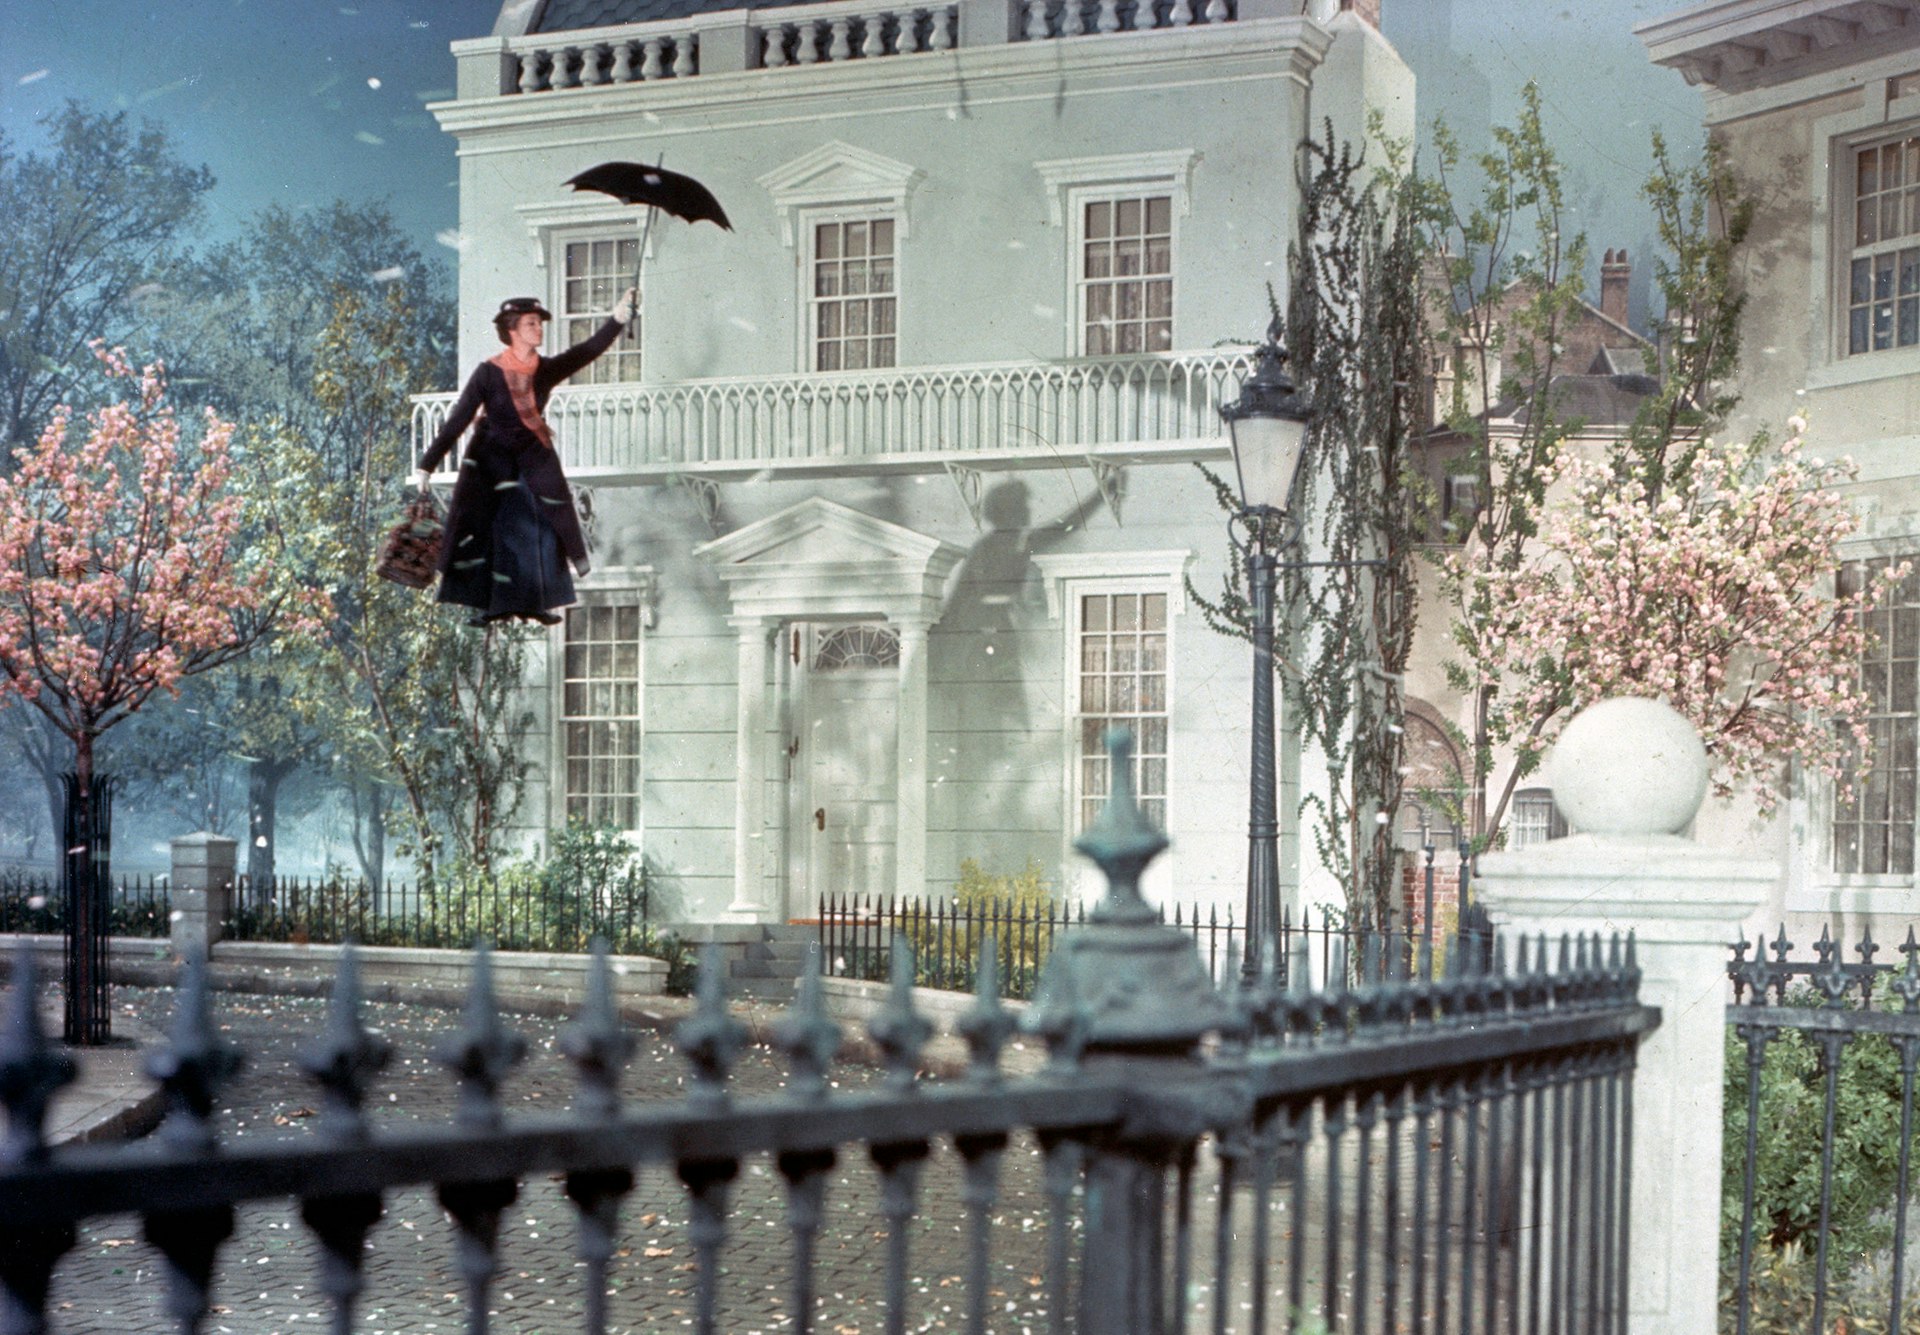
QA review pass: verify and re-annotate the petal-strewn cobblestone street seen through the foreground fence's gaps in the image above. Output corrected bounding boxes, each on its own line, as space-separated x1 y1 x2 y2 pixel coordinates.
48 987 1046 1335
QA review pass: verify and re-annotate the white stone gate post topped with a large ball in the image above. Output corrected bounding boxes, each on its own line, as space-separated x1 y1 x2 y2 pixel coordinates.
1478 699 1778 1335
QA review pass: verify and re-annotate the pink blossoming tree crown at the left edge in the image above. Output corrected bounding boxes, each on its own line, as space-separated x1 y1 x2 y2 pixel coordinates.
0 344 282 799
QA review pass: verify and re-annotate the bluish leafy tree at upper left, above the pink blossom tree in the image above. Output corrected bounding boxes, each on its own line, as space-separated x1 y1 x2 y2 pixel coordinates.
0 102 213 455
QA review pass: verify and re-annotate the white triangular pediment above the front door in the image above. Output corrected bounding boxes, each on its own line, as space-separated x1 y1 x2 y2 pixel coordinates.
693 496 966 624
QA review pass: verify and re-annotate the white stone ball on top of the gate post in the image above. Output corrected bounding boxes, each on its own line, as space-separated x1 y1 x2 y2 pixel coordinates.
1546 695 1707 836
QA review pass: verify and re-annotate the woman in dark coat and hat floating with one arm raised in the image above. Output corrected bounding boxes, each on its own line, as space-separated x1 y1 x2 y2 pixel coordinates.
413 288 636 626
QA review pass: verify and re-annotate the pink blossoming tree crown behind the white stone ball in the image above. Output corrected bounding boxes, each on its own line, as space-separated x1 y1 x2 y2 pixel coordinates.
1450 417 1881 811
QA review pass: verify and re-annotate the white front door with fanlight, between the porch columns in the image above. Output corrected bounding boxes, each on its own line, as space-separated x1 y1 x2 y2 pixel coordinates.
797 622 900 914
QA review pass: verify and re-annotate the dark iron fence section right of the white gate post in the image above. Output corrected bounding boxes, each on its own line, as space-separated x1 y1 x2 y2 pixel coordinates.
1720 928 1920 1335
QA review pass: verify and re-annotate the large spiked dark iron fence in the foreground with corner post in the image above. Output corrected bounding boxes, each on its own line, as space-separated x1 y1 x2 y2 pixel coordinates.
0 737 1659 1335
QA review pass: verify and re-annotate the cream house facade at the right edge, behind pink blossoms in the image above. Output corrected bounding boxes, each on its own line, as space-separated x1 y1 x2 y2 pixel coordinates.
1636 0 1920 939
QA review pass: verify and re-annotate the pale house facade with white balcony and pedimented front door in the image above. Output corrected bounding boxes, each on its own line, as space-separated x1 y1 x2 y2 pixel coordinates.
415 0 1411 924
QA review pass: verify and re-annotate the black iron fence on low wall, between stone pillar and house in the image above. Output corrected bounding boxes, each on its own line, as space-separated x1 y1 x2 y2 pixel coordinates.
225 866 655 953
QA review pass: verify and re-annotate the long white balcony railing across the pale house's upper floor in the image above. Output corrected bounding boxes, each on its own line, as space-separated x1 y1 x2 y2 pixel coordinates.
413 350 1252 478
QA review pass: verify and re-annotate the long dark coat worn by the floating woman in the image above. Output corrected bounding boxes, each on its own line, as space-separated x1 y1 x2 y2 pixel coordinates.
420 319 620 613
